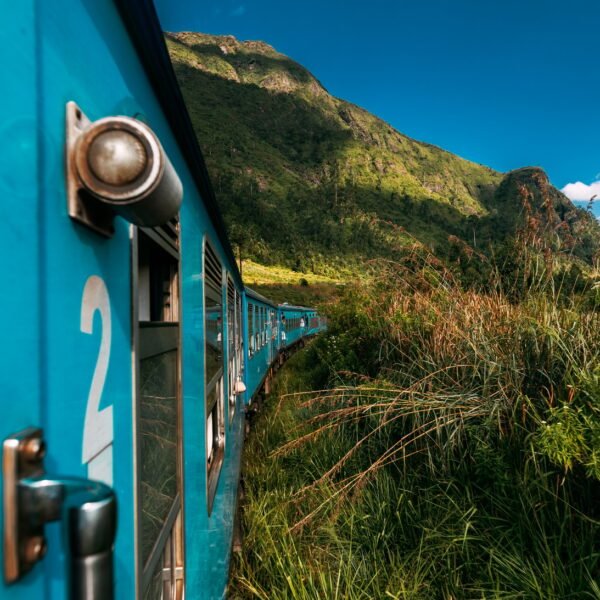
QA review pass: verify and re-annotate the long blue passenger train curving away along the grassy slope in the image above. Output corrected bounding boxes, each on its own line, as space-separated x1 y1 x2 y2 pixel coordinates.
0 0 325 600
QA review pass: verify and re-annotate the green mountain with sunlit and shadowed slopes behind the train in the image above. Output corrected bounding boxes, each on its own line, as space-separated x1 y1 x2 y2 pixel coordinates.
166 32 600 271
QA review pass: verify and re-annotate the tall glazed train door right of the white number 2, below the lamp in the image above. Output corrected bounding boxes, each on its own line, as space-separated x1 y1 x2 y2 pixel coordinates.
132 226 184 600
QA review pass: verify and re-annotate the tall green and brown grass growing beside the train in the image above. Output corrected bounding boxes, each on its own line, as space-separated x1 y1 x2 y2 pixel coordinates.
233 246 600 599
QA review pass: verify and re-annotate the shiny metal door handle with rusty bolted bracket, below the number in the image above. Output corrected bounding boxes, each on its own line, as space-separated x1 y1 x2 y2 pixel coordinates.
2 427 117 600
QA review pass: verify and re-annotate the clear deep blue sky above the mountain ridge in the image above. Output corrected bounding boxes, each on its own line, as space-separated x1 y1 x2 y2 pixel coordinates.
155 0 600 199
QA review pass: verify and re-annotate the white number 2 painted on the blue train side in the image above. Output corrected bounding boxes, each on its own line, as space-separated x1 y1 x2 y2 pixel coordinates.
81 275 113 485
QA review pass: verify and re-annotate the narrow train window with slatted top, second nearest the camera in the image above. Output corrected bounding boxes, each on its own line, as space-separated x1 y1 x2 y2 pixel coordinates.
204 242 225 513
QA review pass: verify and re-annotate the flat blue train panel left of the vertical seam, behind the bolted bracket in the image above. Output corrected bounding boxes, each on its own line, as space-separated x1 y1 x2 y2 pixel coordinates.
0 0 45 600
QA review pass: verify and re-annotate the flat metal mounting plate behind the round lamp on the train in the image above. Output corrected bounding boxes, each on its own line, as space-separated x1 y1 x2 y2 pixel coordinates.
66 102 115 237
